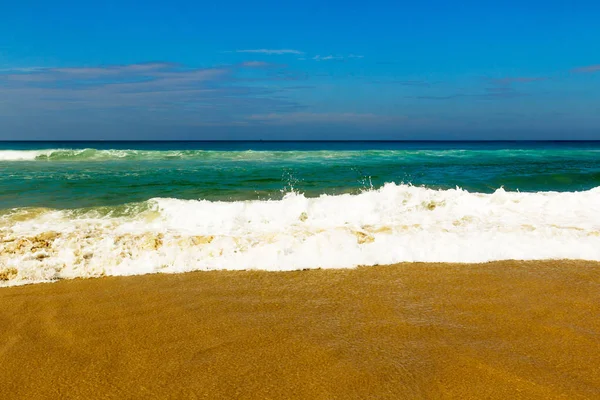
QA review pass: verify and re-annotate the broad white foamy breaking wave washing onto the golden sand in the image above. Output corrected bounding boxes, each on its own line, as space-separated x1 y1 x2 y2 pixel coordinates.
0 184 600 286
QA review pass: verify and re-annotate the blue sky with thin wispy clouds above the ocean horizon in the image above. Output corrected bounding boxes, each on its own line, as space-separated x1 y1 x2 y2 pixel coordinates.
0 0 600 140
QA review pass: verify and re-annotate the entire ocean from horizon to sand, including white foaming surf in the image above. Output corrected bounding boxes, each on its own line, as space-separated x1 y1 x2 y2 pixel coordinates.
0 142 600 286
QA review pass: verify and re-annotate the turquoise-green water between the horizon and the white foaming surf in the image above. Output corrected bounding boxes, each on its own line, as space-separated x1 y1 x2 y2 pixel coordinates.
0 142 600 209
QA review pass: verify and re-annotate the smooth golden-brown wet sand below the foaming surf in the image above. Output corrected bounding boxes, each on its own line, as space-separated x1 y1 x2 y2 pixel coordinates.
0 261 600 399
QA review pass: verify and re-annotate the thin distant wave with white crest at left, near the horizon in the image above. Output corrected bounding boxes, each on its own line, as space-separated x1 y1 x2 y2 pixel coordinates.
0 148 600 162
